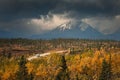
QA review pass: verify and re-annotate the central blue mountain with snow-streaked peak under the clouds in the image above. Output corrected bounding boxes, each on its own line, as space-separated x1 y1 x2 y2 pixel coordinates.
32 22 103 39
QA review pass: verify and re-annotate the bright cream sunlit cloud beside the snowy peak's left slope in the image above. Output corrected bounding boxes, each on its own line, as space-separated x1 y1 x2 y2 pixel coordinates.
30 13 73 30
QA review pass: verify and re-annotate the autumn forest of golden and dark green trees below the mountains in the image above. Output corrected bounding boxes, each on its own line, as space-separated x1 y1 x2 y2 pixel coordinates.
0 38 120 80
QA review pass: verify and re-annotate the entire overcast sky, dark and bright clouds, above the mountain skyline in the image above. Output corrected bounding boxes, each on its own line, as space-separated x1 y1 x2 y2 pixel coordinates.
0 0 120 35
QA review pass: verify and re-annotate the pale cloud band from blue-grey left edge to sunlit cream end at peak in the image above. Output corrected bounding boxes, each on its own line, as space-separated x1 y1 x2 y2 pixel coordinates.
0 12 74 35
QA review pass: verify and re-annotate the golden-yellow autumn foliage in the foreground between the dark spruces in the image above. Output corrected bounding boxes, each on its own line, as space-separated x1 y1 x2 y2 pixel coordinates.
0 50 120 80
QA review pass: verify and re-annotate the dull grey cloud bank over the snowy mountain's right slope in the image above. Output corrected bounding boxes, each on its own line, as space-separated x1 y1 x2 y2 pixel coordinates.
82 15 120 34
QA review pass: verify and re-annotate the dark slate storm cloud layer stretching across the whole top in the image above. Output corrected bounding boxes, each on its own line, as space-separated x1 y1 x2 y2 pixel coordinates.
0 0 120 21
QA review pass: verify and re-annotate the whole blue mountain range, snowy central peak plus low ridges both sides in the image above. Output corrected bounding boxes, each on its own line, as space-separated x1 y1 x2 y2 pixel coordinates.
0 21 120 40
